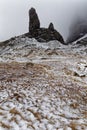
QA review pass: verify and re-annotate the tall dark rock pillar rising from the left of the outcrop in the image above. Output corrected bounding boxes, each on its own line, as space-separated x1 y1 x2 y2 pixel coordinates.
29 8 40 34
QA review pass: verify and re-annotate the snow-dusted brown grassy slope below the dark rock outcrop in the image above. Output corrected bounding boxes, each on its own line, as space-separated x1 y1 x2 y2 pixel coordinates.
0 36 87 130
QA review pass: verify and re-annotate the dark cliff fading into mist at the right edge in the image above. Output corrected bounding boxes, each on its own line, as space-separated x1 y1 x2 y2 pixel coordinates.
67 19 87 43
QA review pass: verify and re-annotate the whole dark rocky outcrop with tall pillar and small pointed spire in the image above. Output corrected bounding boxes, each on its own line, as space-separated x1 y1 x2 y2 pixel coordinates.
29 8 64 43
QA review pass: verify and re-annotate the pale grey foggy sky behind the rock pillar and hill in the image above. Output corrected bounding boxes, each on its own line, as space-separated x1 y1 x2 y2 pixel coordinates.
0 0 87 41
